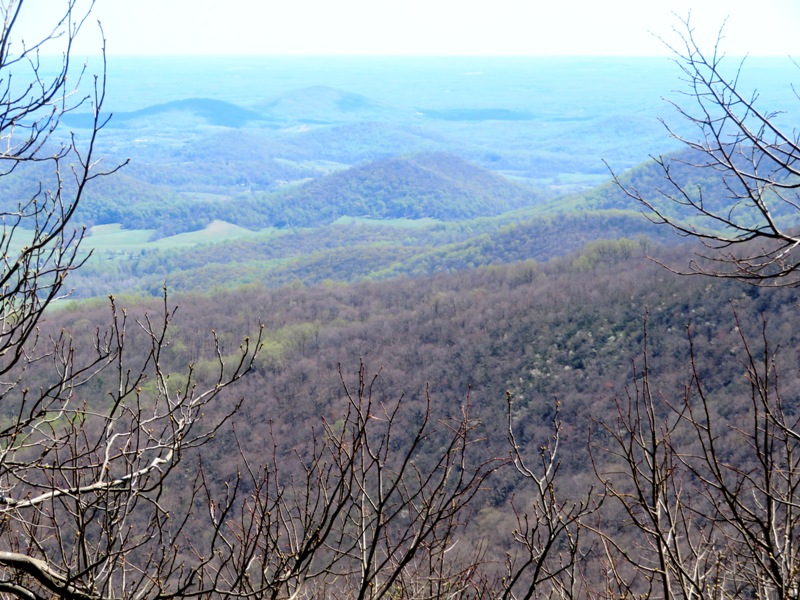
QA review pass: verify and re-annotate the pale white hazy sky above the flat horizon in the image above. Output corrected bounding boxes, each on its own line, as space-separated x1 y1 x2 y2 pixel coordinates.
40 0 800 56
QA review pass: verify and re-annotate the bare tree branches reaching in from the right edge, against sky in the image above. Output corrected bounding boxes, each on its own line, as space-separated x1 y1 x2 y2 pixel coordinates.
612 13 800 286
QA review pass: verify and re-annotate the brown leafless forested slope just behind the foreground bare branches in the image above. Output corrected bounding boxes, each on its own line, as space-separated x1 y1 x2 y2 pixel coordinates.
43 242 800 592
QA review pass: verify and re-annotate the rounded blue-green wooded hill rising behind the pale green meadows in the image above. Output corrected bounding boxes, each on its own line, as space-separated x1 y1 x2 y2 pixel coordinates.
0 149 544 237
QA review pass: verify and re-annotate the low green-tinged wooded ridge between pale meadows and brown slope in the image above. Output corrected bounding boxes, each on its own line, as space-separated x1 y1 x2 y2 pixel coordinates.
71 211 676 297
